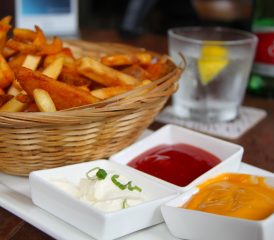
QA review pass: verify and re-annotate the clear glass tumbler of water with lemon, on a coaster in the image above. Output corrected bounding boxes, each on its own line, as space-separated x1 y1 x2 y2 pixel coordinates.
168 27 258 122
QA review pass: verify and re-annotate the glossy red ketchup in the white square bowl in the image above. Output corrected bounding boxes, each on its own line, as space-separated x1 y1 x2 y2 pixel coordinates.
128 144 221 187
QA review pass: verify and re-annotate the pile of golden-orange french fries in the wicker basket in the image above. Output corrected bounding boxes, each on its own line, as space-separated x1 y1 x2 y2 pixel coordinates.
0 16 170 112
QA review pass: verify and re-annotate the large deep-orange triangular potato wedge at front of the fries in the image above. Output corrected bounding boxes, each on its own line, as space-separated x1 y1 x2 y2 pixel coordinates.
15 67 98 110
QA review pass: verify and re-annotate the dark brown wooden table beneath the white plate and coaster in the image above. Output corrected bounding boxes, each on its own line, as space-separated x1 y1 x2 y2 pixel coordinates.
0 29 274 240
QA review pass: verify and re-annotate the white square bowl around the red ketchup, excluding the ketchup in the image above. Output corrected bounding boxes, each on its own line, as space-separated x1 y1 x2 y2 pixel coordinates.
109 125 243 192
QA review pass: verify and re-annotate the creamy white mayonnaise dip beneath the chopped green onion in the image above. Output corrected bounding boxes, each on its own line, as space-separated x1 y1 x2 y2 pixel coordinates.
51 168 145 212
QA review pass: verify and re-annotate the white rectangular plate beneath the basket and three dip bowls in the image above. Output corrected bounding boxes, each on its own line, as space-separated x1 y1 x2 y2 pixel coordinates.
0 163 274 240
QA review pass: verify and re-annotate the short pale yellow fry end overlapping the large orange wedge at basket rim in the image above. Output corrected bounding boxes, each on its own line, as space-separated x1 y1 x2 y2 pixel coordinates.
33 88 56 112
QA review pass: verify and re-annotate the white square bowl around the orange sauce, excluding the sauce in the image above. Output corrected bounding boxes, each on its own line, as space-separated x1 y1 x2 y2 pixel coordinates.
161 173 274 240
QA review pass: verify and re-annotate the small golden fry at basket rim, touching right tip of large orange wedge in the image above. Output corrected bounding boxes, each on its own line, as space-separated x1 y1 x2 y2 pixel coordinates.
90 85 133 99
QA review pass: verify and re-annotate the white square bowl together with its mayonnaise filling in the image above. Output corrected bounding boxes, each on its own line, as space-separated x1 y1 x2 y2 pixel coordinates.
30 160 178 240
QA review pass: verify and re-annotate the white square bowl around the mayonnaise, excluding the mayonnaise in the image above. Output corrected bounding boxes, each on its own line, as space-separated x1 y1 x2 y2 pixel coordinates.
29 160 178 239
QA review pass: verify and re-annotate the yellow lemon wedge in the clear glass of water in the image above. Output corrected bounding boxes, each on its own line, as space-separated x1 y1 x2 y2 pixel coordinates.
198 45 229 85
